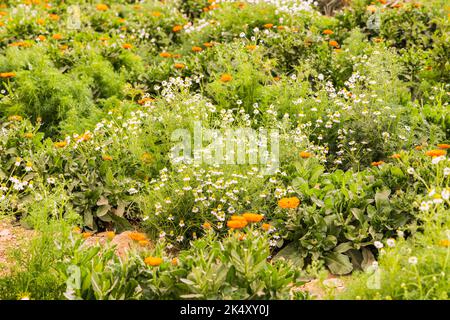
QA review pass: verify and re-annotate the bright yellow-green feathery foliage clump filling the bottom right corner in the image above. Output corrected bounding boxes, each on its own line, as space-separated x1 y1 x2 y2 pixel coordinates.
337 205 450 300
